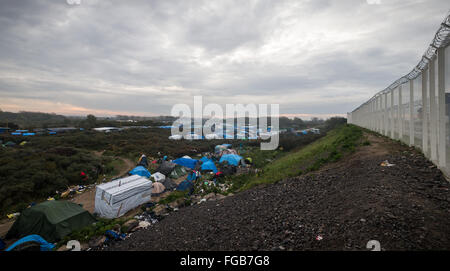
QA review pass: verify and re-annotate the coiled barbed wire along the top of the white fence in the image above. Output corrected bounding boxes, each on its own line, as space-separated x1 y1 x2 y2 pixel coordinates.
352 12 450 112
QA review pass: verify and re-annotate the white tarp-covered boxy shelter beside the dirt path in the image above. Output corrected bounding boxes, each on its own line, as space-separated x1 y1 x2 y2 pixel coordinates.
95 175 152 218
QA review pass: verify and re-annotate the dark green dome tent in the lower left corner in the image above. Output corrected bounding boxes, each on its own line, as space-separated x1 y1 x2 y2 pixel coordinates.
6 200 96 242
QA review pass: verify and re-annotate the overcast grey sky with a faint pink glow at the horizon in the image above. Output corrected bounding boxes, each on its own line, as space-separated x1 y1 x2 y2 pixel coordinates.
0 0 450 117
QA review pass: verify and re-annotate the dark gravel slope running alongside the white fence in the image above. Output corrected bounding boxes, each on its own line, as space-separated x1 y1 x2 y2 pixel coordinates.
108 135 450 250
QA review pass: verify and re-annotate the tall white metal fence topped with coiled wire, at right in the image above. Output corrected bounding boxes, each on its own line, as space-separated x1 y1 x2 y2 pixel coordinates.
347 15 450 176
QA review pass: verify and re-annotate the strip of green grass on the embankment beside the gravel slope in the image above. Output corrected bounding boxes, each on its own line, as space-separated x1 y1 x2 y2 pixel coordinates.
228 125 363 192
